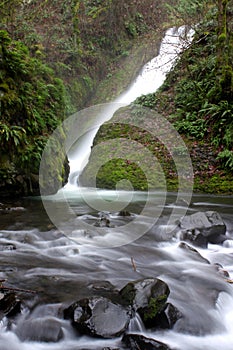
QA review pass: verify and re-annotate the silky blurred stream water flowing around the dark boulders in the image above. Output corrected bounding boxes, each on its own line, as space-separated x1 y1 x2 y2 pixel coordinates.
0 28 233 350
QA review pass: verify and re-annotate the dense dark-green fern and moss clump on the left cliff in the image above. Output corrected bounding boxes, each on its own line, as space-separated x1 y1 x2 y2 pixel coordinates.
0 31 66 191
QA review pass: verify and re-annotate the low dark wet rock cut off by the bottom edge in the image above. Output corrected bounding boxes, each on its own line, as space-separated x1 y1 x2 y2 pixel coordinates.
122 334 170 350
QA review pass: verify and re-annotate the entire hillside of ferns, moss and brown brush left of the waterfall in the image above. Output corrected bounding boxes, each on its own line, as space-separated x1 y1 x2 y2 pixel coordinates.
0 0 171 195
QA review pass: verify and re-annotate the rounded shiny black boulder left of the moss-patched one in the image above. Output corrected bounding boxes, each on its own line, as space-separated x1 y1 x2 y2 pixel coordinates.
64 297 130 338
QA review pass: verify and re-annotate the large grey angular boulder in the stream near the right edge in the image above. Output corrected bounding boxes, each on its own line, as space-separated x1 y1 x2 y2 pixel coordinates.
179 211 227 247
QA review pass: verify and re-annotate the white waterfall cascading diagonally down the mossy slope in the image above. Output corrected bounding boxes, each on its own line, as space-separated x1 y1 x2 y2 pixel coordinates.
65 26 194 189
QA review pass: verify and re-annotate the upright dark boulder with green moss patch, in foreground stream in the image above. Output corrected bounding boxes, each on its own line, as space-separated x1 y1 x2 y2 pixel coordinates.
120 278 170 328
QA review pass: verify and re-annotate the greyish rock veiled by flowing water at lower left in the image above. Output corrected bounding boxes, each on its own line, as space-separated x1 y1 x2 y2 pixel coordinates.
16 317 63 343
